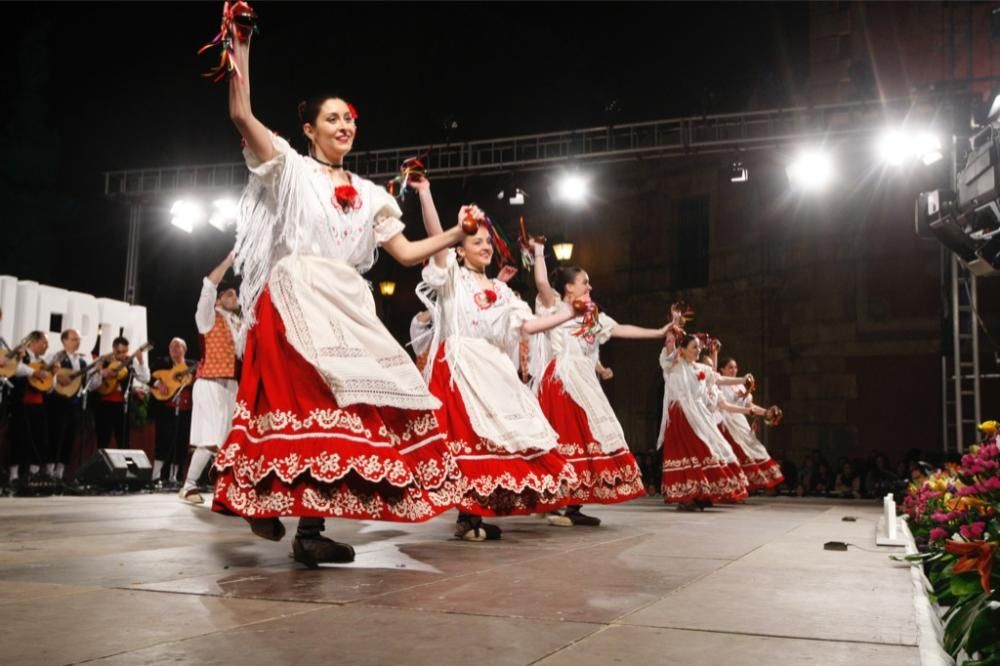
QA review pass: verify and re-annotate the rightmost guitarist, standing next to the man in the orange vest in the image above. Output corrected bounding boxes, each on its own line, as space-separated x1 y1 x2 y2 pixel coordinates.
150 338 196 487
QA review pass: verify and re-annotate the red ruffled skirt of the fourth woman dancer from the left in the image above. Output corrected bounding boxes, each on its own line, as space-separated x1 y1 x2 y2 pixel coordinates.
661 403 747 504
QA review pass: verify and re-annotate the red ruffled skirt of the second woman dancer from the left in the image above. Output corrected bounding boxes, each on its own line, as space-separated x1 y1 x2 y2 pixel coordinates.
429 344 576 516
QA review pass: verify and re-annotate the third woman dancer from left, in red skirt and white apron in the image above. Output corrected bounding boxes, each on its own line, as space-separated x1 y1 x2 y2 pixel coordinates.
530 240 667 527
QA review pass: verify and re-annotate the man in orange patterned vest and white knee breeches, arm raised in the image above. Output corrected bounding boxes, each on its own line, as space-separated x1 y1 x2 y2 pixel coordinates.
180 254 240 504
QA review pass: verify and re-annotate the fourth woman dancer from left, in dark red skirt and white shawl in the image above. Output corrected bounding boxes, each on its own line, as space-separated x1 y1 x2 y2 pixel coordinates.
660 329 747 510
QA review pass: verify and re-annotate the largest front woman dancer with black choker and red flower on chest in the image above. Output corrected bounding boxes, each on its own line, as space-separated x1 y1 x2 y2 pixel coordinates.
213 20 472 567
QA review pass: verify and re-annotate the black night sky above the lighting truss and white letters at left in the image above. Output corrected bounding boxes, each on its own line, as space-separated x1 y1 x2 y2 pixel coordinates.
0 2 808 352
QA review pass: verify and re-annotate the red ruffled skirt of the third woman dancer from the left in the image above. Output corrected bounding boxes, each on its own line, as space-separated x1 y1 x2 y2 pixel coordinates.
538 361 646 504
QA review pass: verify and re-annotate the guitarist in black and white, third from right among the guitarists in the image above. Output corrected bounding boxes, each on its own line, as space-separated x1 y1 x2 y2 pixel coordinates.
45 328 88 481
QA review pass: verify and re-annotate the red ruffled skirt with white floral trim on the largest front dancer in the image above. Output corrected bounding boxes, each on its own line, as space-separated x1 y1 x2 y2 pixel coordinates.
212 289 457 522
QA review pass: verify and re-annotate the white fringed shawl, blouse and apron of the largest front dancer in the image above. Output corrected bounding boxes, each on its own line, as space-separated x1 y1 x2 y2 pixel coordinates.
235 137 441 410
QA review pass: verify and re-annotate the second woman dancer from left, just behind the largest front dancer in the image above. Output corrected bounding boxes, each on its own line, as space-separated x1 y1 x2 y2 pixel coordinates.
417 198 577 541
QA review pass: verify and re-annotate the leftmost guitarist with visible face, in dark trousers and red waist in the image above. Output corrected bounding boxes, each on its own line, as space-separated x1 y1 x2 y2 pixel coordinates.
10 331 53 486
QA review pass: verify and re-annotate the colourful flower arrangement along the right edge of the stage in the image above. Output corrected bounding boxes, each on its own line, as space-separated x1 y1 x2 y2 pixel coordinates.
896 421 1000 666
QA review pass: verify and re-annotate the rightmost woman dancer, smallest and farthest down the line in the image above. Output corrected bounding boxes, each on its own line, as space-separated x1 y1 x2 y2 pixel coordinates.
716 352 785 492
